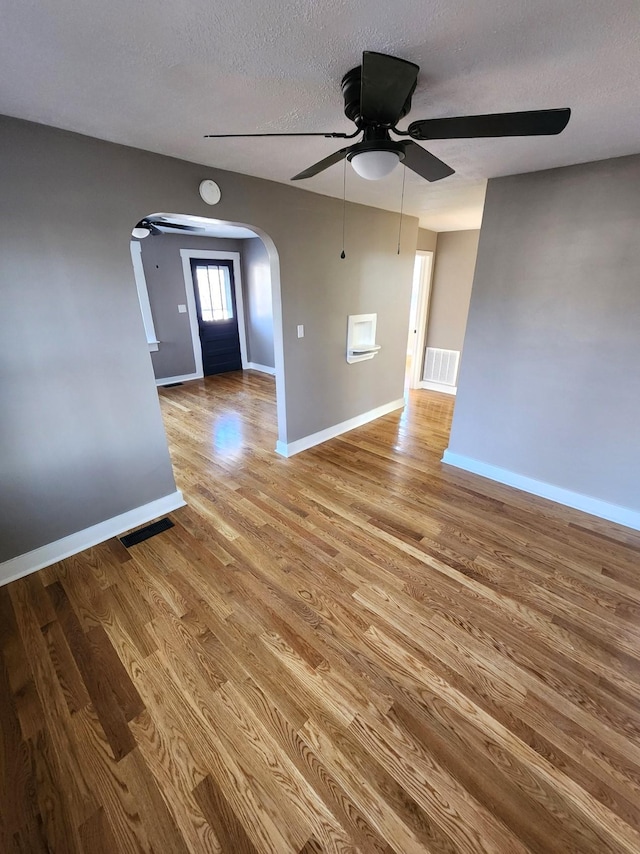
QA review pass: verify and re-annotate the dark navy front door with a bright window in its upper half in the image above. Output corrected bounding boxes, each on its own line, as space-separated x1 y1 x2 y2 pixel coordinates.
191 258 242 377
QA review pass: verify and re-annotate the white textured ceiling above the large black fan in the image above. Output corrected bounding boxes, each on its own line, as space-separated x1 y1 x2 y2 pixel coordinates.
0 0 640 230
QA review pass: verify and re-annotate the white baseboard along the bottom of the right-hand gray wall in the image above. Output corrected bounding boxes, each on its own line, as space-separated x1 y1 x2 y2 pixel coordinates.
442 449 640 531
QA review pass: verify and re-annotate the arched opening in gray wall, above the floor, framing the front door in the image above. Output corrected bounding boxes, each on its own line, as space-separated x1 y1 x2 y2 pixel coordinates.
131 213 286 452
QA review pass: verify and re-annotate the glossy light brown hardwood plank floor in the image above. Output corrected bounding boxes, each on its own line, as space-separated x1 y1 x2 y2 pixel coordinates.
0 373 640 854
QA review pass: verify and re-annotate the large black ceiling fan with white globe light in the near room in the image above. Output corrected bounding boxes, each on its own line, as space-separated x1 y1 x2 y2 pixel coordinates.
206 51 571 181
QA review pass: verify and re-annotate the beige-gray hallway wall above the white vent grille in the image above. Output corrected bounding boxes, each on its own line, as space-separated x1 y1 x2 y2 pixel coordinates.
427 231 480 350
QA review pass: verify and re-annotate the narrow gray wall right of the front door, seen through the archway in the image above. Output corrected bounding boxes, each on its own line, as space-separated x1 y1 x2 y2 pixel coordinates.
242 237 276 368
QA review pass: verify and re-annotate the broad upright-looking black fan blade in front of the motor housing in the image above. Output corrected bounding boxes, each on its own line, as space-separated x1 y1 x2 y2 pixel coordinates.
360 50 420 127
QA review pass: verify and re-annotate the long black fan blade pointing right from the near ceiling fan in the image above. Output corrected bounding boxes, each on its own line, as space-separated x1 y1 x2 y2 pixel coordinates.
408 108 571 139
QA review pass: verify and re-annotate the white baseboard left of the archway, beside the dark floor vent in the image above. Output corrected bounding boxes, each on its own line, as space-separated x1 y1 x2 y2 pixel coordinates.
0 489 186 585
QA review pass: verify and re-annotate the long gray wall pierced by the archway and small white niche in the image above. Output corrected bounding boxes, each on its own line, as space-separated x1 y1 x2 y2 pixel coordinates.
0 118 417 560
